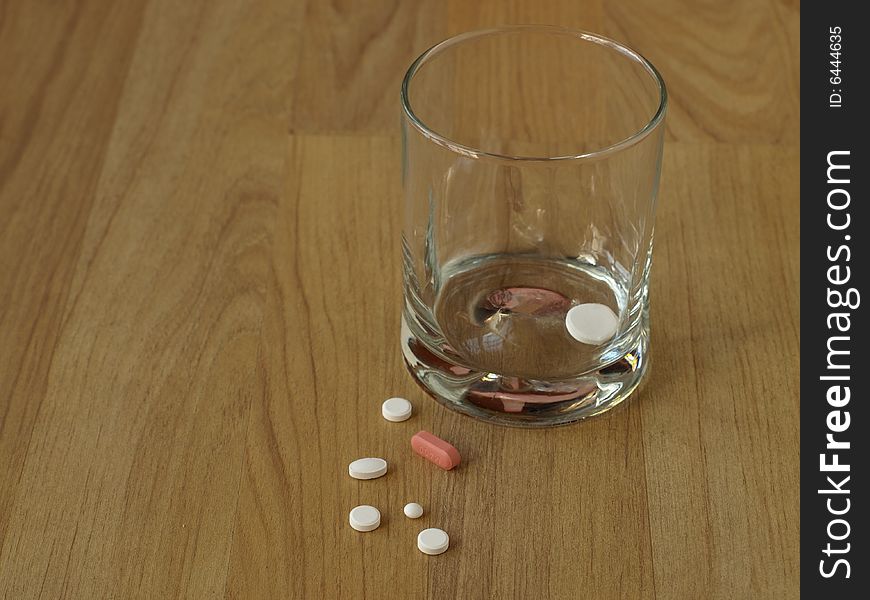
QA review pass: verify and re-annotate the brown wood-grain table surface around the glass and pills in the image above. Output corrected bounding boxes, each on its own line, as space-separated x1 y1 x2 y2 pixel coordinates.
0 0 800 600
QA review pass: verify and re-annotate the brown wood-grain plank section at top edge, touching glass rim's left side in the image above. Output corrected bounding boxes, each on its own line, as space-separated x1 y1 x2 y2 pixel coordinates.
290 0 445 133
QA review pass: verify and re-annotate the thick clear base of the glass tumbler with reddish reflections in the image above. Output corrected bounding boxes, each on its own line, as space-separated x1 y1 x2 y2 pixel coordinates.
402 315 649 427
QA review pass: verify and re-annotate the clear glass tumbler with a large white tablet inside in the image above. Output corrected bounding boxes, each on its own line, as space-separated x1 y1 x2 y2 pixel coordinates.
401 26 667 427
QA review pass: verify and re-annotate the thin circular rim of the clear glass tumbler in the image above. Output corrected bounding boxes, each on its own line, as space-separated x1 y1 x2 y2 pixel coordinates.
401 25 668 162
